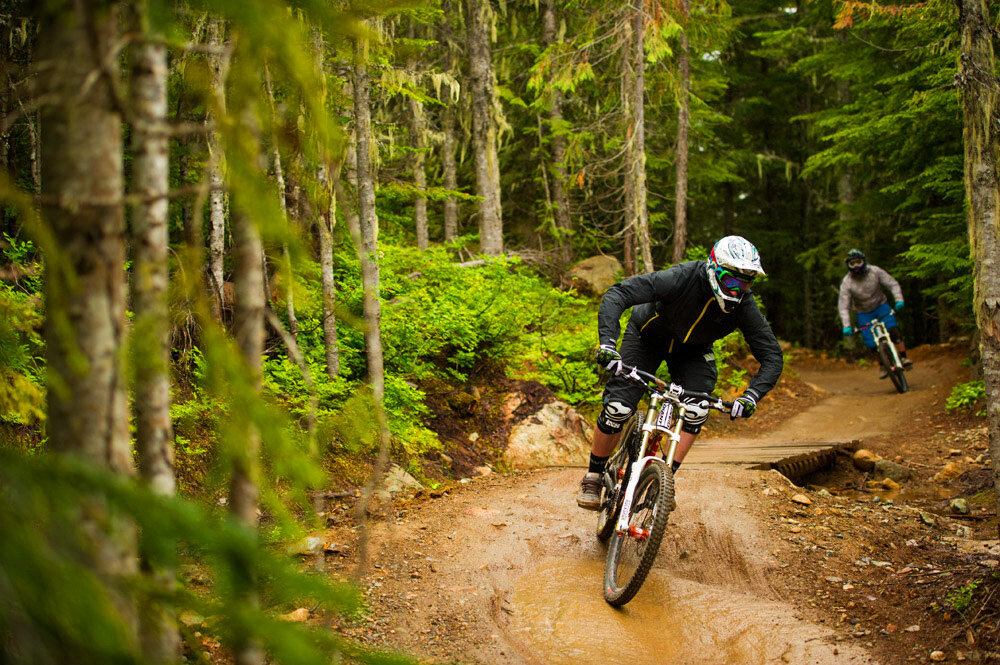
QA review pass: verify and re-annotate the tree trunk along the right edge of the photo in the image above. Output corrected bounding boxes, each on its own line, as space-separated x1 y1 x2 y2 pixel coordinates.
958 0 1000 536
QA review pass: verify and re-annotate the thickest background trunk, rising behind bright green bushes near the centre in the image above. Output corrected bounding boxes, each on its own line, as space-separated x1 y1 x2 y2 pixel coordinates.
466 0 503 256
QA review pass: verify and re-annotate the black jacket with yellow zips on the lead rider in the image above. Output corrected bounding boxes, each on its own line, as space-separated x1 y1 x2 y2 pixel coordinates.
597 261 784 396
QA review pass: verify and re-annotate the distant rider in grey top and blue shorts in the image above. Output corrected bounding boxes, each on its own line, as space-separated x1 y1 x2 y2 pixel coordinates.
837 249 913 379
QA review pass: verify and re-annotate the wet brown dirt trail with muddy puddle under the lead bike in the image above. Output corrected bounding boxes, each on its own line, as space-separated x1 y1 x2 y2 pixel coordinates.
347 350 961 665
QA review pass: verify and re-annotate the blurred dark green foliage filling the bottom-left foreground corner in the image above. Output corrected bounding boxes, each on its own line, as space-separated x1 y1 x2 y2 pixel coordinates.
0 449 409 665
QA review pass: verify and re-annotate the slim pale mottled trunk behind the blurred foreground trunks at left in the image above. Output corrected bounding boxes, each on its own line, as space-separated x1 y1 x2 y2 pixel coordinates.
208 18 229 322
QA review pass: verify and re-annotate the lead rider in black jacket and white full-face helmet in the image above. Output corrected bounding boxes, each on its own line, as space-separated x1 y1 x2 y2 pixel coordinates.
576 236 783 510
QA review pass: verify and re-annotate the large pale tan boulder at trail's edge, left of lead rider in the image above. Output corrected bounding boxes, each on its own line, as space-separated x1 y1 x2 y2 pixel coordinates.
504 401 593 469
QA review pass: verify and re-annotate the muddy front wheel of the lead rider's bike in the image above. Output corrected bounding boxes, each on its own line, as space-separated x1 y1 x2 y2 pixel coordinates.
604 462 674 607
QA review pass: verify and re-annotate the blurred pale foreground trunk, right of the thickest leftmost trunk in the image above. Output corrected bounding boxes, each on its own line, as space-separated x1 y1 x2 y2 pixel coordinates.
131 10 180 664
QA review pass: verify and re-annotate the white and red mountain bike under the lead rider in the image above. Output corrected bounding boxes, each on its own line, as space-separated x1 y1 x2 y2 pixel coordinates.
597 365 733 607
